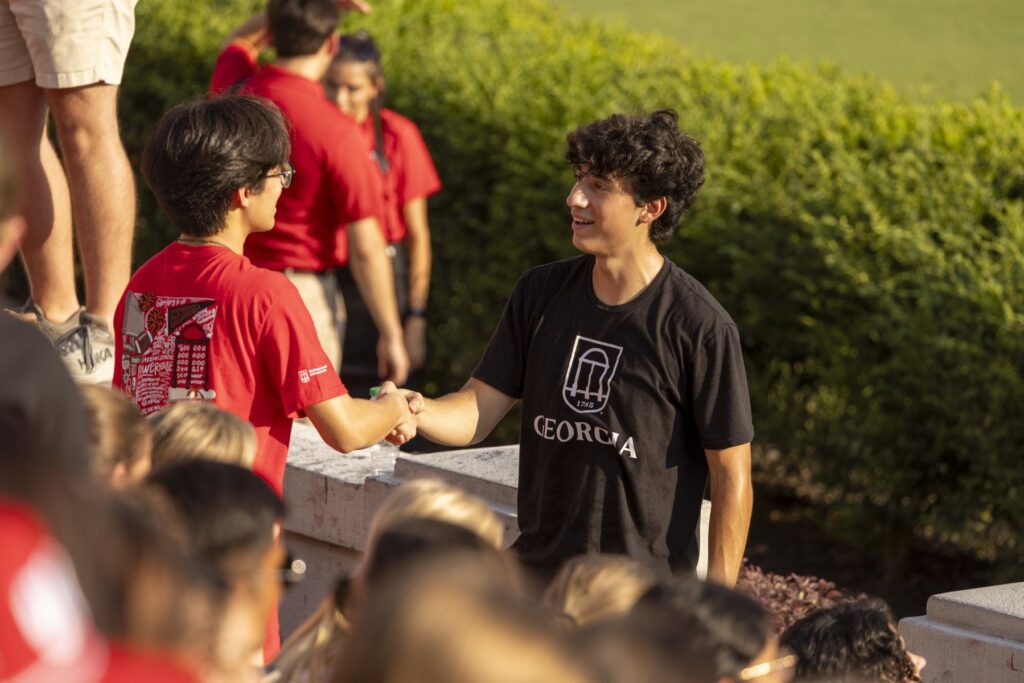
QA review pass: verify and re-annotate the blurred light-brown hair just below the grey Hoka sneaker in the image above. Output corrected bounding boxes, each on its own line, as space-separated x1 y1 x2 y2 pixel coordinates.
79 384 152 480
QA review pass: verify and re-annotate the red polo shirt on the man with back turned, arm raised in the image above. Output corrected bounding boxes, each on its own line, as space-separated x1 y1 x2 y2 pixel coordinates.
210 42 383 271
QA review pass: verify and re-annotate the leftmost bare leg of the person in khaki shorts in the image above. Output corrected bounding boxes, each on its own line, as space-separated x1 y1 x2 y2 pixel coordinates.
0 81 78 323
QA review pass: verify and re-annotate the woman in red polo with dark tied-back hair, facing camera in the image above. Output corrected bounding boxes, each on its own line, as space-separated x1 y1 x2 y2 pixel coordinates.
324 31 441 394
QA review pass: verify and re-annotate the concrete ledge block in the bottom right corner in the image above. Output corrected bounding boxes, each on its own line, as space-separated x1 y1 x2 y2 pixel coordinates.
899 584 1024 683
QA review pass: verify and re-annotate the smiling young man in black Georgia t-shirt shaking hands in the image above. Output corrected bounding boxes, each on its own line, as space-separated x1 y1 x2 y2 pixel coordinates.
409 111 754 585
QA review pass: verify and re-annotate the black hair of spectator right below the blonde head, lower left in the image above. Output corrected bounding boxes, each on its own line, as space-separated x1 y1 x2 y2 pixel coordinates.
146 460 285 580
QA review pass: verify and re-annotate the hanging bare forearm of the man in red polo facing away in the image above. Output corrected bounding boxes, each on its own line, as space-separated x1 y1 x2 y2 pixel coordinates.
346 218 402 339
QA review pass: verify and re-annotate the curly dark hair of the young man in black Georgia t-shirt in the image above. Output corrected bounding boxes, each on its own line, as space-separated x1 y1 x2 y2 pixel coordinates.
565 110 705 243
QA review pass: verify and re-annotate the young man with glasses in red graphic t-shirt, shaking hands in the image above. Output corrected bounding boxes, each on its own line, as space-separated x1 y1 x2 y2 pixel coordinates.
114 96 415 494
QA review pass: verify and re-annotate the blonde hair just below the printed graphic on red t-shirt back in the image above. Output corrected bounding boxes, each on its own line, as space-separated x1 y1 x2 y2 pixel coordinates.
150 400 256 469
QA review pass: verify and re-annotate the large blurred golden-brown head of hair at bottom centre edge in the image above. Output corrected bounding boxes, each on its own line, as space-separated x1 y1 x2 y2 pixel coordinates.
334 553 588 683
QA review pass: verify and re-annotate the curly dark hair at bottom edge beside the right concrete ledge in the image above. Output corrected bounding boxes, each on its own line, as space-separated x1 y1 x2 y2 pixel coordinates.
780 600 921 683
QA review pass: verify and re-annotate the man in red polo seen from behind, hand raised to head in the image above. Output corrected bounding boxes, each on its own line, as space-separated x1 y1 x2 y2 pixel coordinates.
210 0 409 384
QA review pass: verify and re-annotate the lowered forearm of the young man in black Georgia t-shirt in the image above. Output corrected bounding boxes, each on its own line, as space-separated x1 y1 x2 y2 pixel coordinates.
708 444 754 586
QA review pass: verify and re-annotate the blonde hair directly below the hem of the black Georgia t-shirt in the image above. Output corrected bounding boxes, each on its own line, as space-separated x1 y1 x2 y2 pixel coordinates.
544 555 656 626
